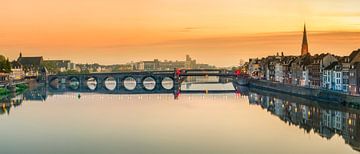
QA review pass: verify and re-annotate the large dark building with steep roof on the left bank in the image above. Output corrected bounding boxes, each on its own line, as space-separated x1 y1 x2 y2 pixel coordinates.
17 53 43 77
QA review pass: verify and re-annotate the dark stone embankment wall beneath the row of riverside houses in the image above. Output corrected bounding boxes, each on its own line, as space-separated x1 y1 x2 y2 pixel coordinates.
249 79 360 106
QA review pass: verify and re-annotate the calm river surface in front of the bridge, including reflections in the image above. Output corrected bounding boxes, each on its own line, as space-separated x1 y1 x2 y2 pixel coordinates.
0 85 360 154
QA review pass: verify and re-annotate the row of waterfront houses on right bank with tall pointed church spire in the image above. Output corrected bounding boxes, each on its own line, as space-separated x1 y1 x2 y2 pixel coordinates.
247 26 360 94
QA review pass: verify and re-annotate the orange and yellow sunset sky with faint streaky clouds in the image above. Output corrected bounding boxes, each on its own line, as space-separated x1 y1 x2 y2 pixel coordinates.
0 0 360 66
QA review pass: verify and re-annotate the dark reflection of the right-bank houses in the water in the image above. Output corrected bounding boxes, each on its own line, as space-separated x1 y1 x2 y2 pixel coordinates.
248 92 360 151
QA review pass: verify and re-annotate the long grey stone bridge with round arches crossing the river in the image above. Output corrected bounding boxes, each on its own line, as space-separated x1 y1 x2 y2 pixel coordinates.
47 69 238 94
